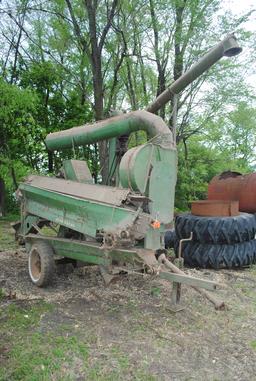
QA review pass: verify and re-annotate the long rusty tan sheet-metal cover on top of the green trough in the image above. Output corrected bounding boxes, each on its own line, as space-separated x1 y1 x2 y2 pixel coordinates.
24 175 130 206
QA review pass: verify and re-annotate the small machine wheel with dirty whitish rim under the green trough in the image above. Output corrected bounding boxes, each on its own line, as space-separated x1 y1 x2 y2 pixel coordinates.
28 241 54 287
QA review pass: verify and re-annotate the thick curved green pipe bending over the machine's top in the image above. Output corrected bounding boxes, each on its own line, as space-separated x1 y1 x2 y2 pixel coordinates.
45 111 173 151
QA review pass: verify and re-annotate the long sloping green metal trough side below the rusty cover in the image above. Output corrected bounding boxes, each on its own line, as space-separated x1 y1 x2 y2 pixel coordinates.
20 184 147 238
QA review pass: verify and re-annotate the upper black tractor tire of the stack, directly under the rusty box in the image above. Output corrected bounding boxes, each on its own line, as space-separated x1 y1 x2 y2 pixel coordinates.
175 213 256 244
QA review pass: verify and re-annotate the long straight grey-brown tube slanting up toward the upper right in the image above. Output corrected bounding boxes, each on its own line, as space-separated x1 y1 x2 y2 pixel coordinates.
146 33 242 113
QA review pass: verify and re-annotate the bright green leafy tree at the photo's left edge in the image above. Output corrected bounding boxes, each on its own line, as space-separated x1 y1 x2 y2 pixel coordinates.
0 79 40 212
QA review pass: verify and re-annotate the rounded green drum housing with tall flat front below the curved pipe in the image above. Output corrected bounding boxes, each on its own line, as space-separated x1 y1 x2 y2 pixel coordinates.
119 143 177 224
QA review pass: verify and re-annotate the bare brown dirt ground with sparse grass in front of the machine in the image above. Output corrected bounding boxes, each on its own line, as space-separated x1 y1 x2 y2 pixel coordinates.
0 218 256 381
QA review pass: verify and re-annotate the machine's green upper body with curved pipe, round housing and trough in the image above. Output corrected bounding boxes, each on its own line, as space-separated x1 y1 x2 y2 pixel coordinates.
20 111 177 254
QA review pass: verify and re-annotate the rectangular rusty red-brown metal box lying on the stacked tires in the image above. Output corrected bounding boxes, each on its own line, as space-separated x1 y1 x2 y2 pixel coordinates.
191 200 239 217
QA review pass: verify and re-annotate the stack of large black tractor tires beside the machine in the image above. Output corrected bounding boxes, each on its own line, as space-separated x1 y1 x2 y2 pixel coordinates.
165 213 256 269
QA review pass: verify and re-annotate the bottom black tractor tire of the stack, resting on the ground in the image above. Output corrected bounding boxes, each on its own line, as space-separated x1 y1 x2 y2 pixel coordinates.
175 239 256 269
